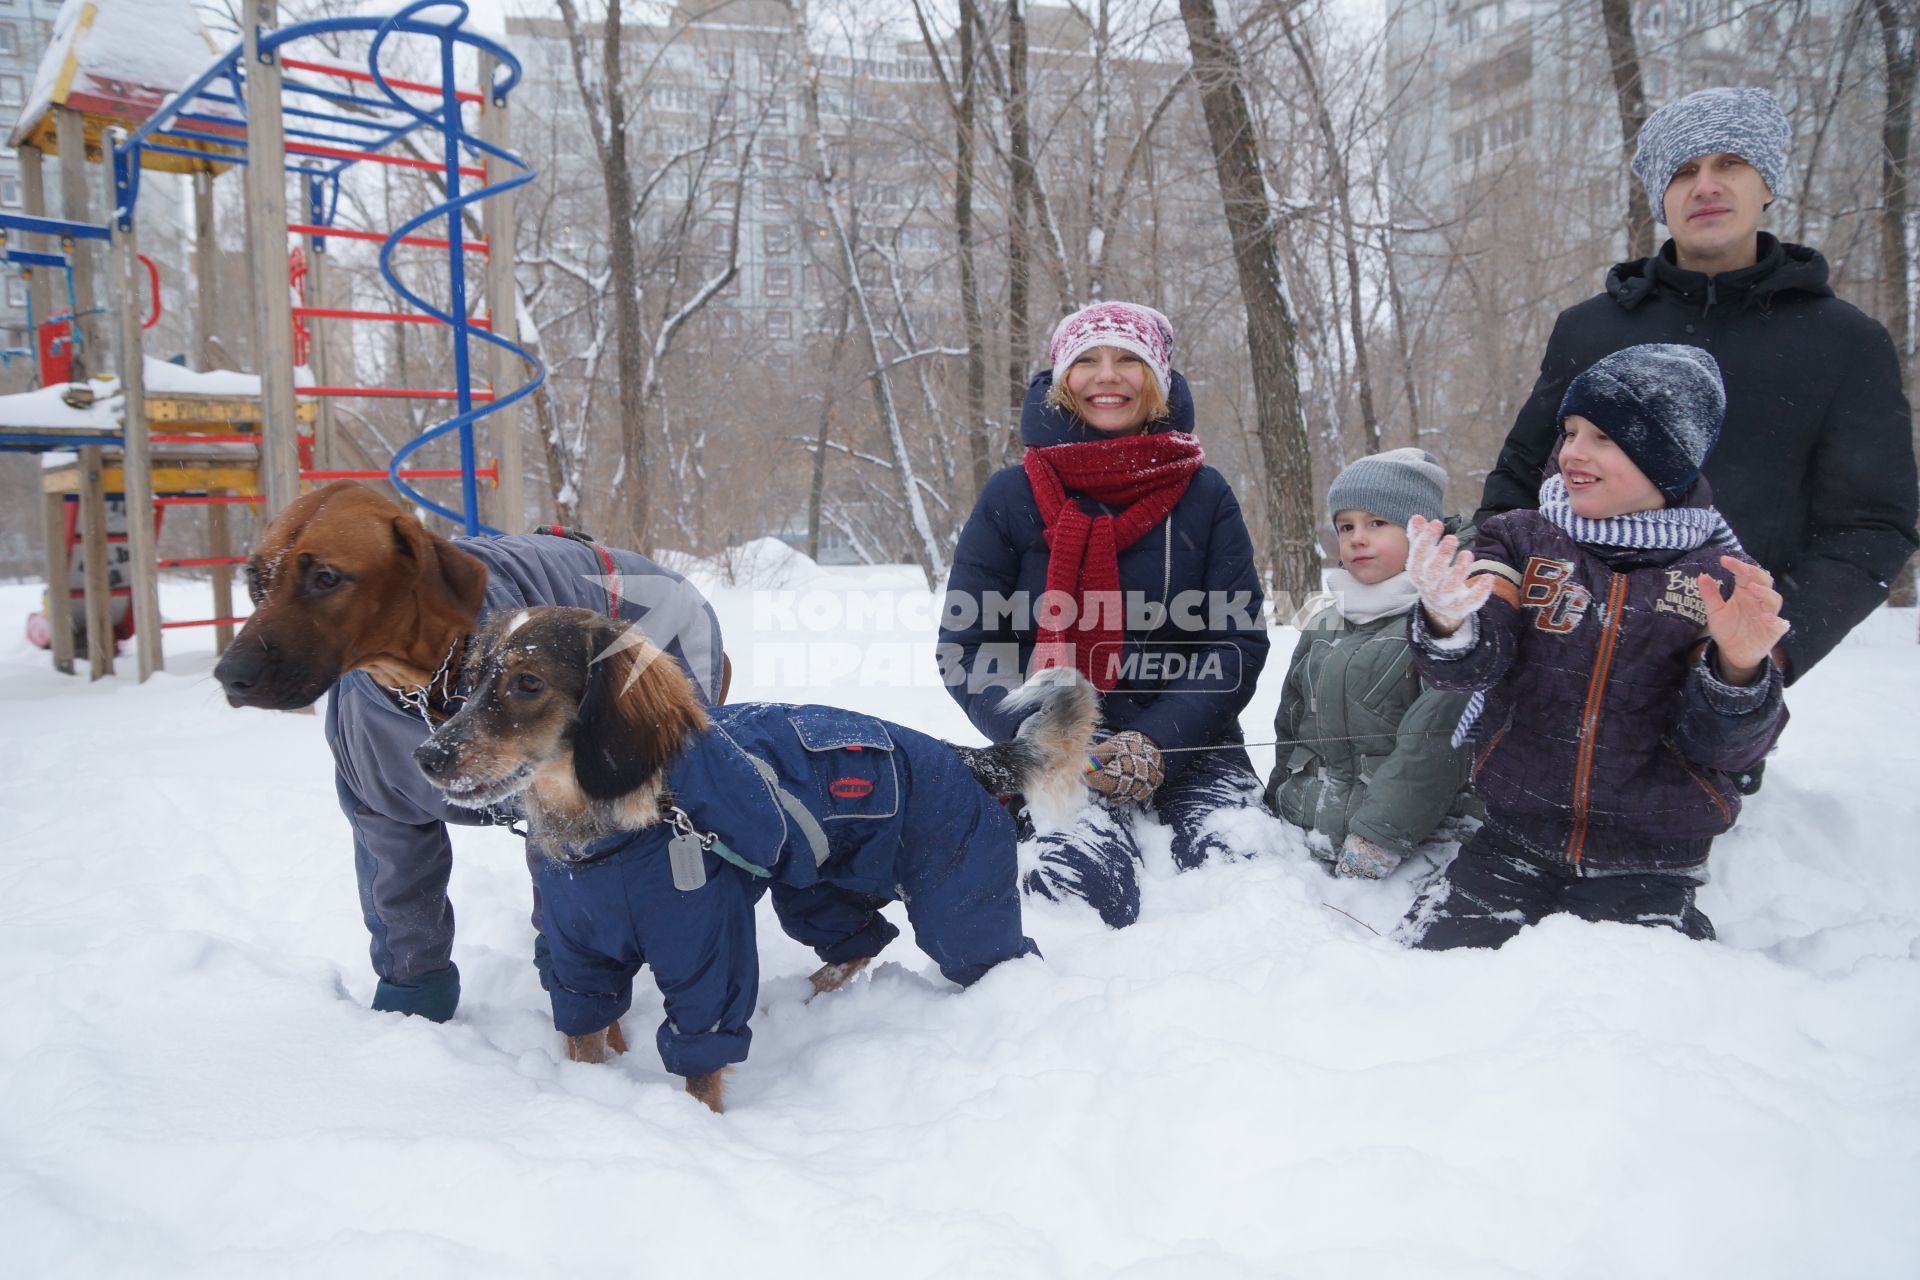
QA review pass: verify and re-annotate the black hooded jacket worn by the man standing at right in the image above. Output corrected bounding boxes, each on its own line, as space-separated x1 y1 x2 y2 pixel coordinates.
1475 232 1920 679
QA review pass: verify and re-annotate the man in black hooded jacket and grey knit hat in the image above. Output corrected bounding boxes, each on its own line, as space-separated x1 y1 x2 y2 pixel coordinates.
1475 88 1920 681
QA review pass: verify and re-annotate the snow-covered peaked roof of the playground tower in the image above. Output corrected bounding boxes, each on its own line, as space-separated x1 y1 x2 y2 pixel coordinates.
8 0 232 169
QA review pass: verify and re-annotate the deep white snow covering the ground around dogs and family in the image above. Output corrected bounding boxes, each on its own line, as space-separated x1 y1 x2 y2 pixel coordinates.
0 564 1920 1280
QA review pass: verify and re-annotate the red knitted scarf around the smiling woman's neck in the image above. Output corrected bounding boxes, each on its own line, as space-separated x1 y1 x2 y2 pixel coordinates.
1025 432 1206 691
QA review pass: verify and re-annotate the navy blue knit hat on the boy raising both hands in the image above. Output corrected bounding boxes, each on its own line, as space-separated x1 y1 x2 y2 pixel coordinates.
1559 342 1726 503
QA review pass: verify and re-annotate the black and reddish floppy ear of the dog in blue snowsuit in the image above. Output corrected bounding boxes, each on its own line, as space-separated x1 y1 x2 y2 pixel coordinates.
574 620 707 800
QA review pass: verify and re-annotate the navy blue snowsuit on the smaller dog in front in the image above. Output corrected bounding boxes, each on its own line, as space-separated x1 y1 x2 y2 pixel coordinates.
540 702 1039 1075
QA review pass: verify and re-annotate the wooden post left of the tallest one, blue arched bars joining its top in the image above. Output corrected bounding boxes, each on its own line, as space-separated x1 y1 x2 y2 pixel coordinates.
100 129 167 681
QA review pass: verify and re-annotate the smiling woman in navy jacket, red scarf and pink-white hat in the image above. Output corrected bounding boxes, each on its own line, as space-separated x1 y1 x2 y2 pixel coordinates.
939 310 1267 929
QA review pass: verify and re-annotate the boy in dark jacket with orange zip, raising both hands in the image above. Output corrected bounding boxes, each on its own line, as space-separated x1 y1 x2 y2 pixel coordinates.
1402 344 1788 950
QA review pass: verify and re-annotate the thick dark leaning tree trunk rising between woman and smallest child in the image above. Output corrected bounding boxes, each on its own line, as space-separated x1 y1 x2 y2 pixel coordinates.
1181 0 1319 602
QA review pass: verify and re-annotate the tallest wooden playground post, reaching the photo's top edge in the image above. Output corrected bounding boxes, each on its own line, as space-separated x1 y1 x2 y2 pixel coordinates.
242 0 300 520
